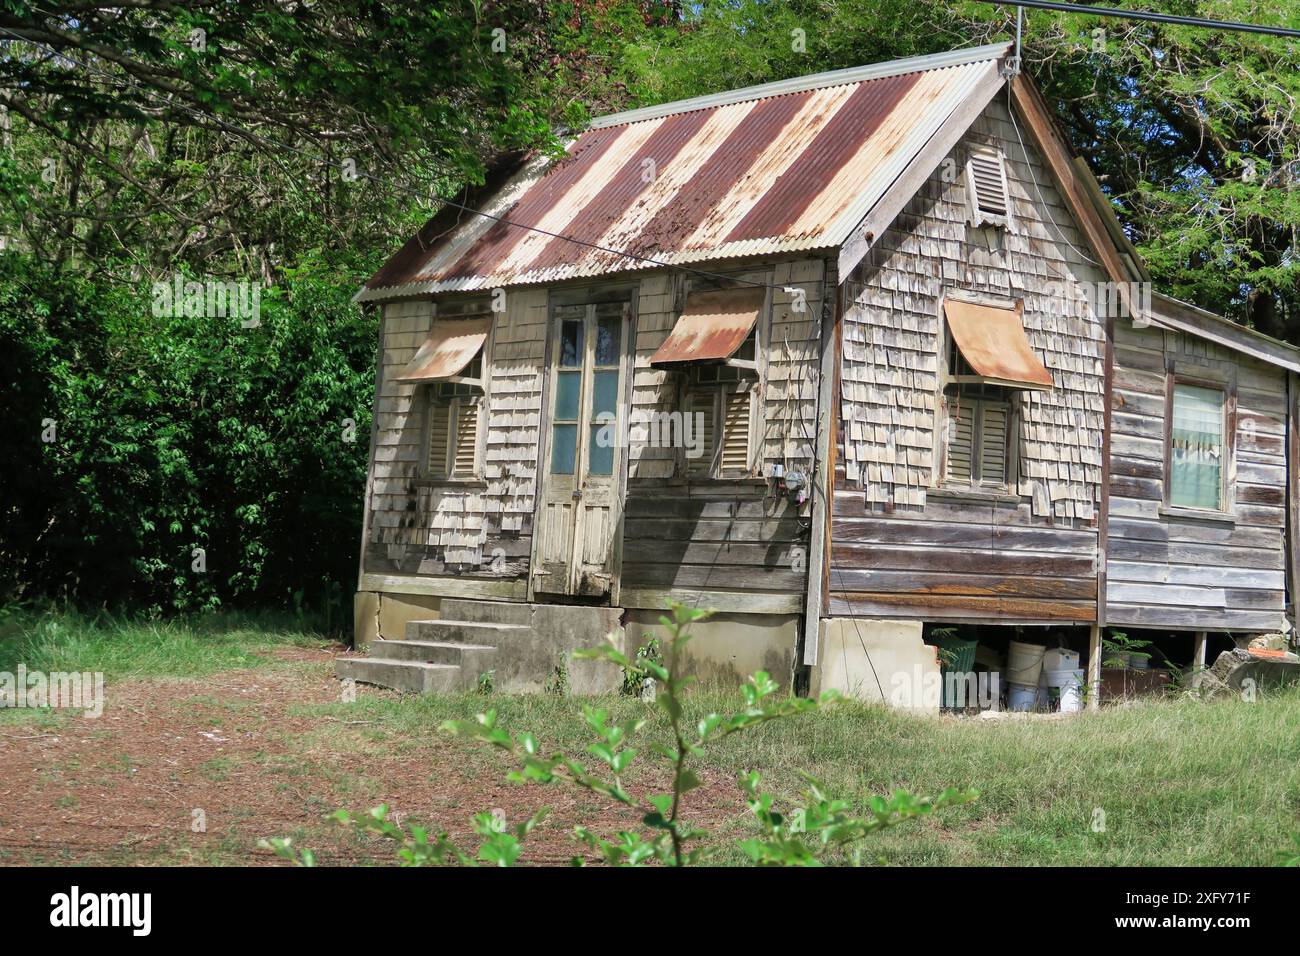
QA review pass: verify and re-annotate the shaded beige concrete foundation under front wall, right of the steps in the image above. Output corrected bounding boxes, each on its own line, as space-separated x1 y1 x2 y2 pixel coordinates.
627 609 800 689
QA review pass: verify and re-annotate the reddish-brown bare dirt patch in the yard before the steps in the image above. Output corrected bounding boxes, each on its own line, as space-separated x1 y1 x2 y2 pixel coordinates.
0 648 737 865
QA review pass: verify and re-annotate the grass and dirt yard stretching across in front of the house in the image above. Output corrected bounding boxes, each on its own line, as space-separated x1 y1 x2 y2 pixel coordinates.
0 615 1300 866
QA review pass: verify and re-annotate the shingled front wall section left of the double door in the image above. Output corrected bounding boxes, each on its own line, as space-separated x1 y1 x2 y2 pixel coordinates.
363 290 546 579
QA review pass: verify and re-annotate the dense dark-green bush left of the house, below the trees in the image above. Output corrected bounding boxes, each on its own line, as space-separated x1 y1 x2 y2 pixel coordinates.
0 254 376 620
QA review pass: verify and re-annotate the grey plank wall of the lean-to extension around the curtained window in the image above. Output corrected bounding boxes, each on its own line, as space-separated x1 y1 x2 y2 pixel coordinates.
1106 320 1287 631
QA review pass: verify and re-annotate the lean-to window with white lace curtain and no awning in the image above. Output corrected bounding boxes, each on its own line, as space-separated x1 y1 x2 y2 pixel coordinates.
1169 382 1225 511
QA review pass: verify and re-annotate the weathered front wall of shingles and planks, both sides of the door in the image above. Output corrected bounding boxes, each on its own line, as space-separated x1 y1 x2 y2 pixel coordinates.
364 254 833 613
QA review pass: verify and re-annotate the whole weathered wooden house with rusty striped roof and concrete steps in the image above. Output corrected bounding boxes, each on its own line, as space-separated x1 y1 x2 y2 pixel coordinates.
339 44 1300 697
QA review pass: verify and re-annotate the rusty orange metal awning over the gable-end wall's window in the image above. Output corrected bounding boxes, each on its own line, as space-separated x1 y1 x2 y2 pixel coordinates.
944 299 1053 392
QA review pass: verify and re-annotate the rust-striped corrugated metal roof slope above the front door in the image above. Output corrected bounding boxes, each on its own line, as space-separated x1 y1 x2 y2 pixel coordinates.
358 43 1008 299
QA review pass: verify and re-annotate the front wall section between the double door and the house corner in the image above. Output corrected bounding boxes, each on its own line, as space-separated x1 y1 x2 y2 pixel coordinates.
619 259 833 614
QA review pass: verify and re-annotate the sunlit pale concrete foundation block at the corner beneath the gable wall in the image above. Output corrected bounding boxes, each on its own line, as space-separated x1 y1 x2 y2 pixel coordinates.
813 618 941 713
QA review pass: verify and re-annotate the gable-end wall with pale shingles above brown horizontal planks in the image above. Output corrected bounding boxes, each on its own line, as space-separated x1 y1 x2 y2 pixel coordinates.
828 100 1105 623
